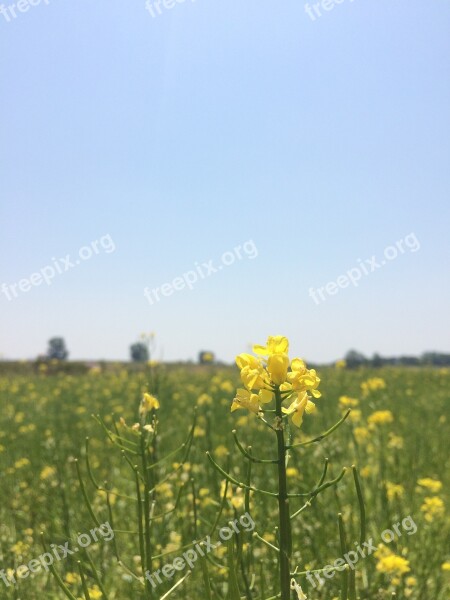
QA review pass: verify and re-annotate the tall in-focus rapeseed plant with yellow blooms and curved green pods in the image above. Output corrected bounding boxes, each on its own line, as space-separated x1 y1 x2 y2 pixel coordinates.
208 336 363 600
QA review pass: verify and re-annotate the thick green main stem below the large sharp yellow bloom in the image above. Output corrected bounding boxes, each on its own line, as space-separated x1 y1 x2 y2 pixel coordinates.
275 387 292 600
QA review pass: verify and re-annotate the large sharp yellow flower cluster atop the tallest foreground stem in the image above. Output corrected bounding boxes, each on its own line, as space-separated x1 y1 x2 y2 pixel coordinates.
231 335 321 427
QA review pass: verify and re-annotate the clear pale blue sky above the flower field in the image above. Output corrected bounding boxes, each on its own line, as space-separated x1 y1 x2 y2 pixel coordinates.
0 0 450 361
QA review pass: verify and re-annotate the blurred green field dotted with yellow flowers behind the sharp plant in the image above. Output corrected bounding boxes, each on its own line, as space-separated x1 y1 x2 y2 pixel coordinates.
0 348 450 600
